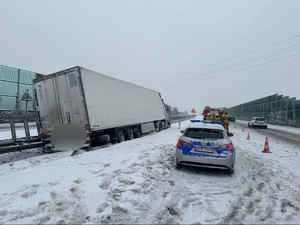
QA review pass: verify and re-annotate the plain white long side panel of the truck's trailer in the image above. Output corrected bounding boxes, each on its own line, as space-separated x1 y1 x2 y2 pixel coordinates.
81 68 166 130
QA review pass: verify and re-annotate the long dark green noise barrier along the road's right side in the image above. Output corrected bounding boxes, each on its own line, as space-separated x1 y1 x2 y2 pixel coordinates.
227 94 300 127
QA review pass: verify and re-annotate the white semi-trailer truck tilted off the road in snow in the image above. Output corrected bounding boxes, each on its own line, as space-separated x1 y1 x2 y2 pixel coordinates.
33 66 170 149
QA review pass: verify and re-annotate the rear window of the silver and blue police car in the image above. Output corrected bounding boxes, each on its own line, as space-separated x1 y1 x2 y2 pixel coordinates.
184 128 224 139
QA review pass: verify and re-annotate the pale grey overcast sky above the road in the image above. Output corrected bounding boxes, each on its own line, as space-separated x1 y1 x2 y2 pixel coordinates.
0 0 300 113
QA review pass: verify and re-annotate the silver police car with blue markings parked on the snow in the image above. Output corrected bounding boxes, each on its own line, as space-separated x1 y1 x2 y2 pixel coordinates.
176 120 235 174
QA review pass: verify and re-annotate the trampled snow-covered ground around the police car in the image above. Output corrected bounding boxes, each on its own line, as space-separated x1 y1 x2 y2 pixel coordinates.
0 117 300 224
